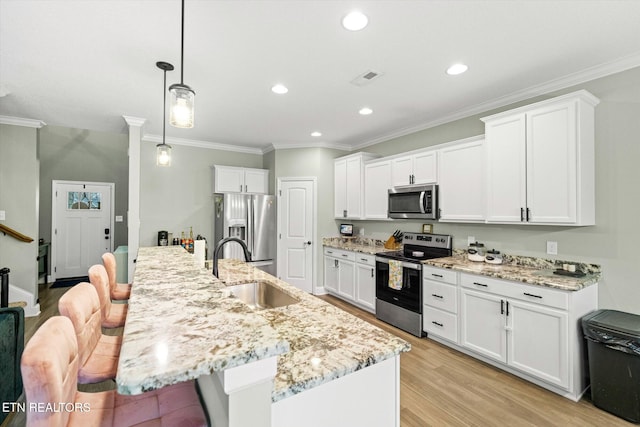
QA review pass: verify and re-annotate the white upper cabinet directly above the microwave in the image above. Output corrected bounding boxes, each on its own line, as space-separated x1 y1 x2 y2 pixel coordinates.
391 150 438 187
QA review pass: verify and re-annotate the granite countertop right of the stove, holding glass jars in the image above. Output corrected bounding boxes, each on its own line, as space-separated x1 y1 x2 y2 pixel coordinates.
422 251 601 291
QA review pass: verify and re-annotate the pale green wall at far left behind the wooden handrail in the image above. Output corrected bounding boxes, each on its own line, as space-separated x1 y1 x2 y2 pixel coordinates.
0 124 39 305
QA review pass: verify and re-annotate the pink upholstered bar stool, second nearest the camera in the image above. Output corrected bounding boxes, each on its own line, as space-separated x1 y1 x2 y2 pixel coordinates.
58 282 122 384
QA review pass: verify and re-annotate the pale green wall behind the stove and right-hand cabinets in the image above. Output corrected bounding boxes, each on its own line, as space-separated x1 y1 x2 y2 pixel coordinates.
350 67 640 314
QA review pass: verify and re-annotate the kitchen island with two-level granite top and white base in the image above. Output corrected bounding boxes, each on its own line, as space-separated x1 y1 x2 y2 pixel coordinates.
116 247 410 427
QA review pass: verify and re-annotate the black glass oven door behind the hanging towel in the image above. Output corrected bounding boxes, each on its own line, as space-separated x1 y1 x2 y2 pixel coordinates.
376 258 422 313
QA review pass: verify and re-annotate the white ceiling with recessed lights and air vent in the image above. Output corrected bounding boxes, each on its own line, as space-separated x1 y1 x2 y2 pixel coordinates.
0 0 640 149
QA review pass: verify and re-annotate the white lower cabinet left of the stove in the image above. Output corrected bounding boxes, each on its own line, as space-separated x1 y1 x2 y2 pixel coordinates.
324 248 376 313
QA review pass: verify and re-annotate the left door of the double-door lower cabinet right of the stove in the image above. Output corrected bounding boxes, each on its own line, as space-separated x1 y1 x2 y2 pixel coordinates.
460 288 507 363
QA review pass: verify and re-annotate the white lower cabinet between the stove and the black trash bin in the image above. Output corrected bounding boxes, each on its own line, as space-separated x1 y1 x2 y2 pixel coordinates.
423 267 598 401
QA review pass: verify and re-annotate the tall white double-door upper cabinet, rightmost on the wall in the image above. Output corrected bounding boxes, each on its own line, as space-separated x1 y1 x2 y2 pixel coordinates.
482 90 599 225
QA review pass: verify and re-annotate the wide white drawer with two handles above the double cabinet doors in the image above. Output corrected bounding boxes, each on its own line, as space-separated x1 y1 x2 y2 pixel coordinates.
460 273 569 310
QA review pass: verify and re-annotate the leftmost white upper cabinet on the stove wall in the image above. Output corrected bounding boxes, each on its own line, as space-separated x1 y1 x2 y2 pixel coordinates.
333 153 377 219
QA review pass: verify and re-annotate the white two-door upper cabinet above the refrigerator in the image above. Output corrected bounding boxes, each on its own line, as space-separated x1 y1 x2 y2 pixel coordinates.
213 165 269 194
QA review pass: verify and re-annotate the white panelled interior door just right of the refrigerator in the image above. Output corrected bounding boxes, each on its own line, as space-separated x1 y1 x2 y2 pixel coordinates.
278 178 316 293
